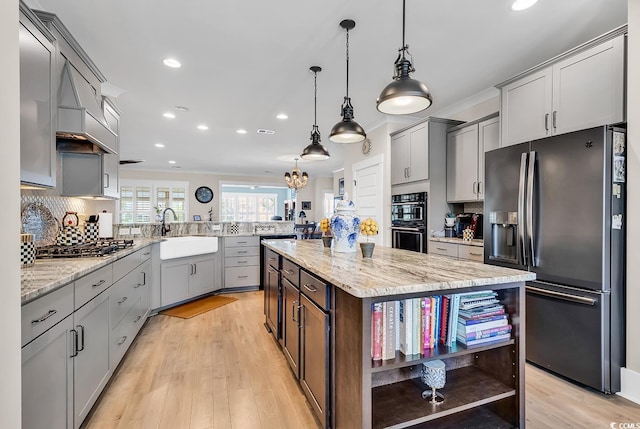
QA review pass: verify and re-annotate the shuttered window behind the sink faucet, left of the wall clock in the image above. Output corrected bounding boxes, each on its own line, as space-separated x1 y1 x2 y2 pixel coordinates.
119 180 189 223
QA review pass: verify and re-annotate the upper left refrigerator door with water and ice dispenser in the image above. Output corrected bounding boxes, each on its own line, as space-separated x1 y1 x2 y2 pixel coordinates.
483 143 529 270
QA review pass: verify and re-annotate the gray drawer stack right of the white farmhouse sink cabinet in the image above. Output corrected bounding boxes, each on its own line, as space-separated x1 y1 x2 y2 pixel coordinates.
224 236 260 288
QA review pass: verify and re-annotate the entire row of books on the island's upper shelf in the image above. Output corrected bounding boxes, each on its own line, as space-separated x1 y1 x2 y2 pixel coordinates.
371 290 511 360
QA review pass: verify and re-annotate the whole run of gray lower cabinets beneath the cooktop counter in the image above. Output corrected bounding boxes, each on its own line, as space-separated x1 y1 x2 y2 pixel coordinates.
22 244 151 429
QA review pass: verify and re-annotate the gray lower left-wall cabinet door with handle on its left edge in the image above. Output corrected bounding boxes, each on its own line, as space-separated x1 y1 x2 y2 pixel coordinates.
73 293 113 429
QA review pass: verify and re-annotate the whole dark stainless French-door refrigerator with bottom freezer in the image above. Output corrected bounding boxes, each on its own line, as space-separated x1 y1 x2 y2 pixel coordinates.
484 126 626 393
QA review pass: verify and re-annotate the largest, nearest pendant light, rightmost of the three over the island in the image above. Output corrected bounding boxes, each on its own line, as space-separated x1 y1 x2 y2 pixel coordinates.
376 0 433 115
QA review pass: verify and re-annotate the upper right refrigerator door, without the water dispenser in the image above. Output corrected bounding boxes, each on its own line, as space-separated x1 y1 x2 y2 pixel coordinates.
528 127 611 290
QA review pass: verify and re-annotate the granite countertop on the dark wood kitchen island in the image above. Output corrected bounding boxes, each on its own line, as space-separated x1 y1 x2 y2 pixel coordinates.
263 240 536 298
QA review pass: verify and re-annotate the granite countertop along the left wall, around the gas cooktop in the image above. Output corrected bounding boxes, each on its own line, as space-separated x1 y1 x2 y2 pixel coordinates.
20 237 162 305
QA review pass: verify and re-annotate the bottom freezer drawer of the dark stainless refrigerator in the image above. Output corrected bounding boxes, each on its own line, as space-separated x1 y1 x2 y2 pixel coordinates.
525 282 620 393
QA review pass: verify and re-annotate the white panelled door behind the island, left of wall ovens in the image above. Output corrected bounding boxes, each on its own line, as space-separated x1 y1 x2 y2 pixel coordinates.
352 155 385 244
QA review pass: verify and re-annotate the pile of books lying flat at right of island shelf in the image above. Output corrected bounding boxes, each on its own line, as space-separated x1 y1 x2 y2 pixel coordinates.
456 290 511 347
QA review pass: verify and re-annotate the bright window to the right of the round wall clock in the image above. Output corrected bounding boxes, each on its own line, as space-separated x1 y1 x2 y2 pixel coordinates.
220 192 278 222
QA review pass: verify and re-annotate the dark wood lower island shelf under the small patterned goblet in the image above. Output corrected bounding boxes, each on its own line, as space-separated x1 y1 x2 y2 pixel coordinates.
371 366 516 429
